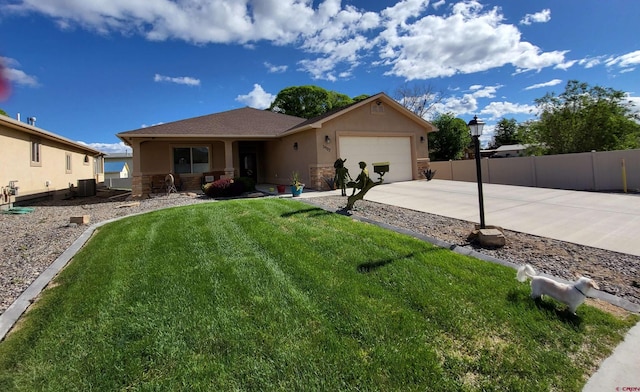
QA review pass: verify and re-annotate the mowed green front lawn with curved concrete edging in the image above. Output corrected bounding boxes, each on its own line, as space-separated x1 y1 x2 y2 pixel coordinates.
0 198 638 391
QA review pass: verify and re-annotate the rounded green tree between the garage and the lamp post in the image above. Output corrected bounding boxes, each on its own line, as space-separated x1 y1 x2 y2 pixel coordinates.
428 113 471 161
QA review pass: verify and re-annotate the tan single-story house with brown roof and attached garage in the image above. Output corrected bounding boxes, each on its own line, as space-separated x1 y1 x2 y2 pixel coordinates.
117 93 436 196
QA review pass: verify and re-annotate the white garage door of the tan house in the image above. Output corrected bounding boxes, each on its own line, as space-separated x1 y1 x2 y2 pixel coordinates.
339 136 413 182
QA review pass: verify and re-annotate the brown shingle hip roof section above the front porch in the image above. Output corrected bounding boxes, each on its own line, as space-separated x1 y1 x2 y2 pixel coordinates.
118 107 306 137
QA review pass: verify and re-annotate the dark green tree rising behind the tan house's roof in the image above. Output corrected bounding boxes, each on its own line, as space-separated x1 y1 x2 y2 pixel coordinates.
269 86 353 118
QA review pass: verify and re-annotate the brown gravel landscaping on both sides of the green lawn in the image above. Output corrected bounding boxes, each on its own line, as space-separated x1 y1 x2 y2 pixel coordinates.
0 193 640 313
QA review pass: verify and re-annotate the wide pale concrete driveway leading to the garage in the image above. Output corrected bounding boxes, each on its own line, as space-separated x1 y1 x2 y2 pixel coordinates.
356 180 640 256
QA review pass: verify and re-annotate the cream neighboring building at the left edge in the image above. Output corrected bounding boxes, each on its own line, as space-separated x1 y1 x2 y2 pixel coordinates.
0 115 104 206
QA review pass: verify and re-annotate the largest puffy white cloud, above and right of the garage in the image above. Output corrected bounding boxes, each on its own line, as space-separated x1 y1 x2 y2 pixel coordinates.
379 0 566 80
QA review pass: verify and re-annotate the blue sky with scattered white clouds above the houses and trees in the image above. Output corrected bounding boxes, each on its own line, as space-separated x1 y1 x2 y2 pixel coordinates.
0 0 640 153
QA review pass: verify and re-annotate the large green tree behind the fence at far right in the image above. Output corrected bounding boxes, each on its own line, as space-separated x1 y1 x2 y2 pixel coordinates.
528 80 640 154
